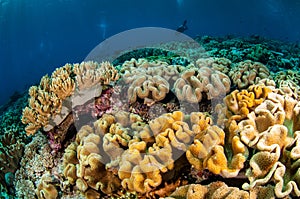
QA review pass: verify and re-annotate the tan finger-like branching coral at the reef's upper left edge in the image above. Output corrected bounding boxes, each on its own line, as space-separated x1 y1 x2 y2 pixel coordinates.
22 62 119 135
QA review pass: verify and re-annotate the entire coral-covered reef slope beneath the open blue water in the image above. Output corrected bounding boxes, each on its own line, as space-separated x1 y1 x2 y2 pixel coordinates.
0 36 300 199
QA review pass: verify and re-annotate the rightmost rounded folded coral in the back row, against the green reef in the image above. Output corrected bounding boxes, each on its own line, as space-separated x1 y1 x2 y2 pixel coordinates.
229 60 270 89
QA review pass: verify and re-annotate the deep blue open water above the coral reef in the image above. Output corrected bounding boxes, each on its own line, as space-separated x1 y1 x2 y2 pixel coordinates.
0 0 300 105
